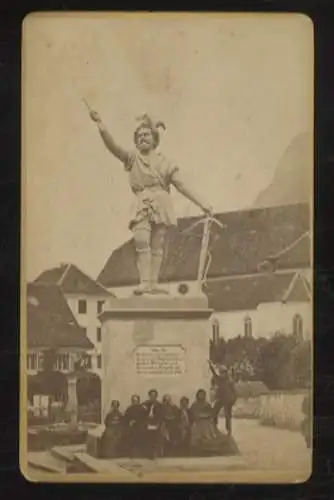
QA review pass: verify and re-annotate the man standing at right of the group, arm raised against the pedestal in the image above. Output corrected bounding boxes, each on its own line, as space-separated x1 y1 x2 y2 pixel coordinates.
209 361 237 436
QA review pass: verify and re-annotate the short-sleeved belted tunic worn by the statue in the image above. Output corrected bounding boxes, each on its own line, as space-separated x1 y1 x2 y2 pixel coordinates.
124 151 179 229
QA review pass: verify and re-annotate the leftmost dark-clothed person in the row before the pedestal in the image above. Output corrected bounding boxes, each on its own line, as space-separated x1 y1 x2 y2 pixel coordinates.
103 400 123 458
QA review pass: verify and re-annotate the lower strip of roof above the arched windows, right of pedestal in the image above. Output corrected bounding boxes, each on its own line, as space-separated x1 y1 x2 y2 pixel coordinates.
204 272 309 312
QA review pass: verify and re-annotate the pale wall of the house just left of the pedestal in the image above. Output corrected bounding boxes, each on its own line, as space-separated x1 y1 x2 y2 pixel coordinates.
65 294 106 376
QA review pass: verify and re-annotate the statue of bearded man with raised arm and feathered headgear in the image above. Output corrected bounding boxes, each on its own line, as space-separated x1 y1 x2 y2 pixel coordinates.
90 111 212 295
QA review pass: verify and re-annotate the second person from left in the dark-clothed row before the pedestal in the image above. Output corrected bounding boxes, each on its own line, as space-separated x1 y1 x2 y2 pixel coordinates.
124 395 146 458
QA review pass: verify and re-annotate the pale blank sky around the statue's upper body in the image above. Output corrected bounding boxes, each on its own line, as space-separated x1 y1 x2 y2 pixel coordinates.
23 14 313 279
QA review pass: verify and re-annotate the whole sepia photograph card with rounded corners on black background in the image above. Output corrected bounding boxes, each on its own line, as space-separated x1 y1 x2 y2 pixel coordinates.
20 12 314 483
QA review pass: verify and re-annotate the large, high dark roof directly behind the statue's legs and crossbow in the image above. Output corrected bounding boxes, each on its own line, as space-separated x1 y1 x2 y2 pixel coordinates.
97 203 310 288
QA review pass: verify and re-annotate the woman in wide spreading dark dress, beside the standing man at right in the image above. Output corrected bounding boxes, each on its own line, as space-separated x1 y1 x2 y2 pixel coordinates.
190 389 239 456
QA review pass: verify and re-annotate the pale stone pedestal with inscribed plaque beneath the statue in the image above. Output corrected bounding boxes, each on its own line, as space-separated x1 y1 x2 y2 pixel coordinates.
99 294 212 421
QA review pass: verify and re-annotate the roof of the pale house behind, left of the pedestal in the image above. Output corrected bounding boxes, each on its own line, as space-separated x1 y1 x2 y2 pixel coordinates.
35 264 111 296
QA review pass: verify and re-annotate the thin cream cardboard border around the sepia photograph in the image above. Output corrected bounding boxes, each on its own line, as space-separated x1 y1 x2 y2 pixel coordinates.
19 11 315 484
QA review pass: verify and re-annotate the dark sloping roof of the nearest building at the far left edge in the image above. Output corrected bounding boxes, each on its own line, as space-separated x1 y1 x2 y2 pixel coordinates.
27 283 94 349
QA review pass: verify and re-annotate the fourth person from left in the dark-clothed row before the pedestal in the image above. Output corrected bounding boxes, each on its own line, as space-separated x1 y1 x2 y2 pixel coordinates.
161 394 181 457
